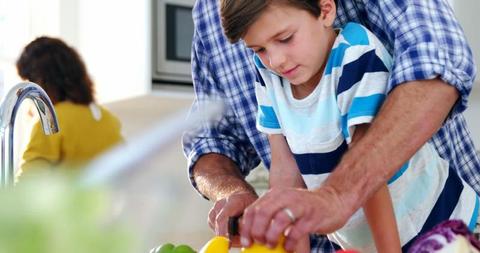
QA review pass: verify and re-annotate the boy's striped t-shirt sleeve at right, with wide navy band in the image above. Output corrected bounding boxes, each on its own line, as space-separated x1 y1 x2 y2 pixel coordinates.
336 24 392 143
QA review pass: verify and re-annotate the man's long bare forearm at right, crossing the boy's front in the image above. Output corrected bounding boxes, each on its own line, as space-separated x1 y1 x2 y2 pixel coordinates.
324 79 458 216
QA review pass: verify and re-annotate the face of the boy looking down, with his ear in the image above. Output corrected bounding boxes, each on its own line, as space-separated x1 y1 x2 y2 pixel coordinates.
243 0 336 89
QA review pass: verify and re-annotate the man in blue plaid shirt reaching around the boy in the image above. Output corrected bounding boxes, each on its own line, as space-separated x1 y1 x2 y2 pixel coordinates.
184 0 480 252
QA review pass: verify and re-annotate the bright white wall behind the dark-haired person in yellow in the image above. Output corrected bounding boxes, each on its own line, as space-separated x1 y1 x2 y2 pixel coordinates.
0 0 151 102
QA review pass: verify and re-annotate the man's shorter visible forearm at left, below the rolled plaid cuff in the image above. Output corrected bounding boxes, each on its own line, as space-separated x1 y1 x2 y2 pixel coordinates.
193 153 255 201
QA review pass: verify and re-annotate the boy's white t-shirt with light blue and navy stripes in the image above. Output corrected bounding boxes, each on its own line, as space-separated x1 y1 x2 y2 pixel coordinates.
254 23 478 252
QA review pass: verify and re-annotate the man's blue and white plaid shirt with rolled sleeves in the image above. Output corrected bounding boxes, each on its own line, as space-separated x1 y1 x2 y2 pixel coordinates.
183 0 480 252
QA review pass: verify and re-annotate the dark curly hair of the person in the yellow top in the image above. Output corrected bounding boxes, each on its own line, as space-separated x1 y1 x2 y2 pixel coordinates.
17 37 94 104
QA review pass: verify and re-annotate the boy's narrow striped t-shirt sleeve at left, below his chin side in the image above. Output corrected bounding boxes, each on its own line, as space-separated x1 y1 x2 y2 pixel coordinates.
254 55 282 134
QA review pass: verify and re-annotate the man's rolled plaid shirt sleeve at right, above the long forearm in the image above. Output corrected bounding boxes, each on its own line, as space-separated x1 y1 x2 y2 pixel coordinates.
365 0 476 113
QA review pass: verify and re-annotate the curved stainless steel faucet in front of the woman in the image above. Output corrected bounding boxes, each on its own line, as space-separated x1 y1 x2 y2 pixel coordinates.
0 82 59 187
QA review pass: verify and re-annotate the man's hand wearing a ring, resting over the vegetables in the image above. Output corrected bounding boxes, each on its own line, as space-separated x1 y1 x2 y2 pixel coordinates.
240 187 349 251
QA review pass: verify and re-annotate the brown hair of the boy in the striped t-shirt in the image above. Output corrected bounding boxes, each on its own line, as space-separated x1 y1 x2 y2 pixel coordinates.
220 0 320 43
